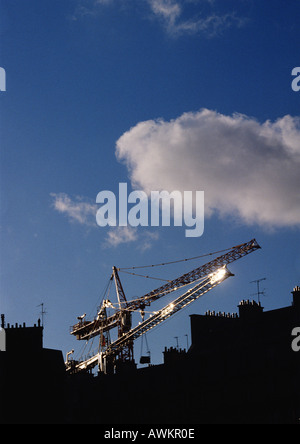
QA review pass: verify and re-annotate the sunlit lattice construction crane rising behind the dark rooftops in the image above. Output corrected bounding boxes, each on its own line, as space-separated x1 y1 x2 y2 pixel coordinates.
66 239 261 373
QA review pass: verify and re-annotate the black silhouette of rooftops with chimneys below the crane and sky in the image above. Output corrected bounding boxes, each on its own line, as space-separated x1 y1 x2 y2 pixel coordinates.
0 287 300 425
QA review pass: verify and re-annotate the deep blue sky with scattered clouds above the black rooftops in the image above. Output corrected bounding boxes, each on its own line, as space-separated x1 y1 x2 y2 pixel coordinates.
0 0 300 363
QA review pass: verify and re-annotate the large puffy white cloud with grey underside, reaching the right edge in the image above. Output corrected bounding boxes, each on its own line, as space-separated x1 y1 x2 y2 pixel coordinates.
116 109 300 227
